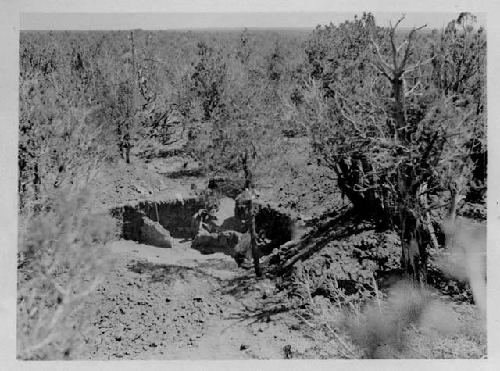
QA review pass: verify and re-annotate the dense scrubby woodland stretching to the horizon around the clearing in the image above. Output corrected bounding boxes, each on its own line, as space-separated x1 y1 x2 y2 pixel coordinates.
19 13 487 357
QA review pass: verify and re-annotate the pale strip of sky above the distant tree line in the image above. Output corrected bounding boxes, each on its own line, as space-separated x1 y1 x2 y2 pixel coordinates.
19 11 486 31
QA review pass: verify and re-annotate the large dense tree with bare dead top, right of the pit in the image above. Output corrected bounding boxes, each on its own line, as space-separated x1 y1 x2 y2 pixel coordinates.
303 14 484 280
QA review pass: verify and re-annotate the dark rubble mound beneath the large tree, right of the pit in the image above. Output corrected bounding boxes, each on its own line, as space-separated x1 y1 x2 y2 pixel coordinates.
266 209 473 303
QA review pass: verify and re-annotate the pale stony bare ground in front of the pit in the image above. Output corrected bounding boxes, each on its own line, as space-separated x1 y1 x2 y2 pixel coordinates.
82 240 333 359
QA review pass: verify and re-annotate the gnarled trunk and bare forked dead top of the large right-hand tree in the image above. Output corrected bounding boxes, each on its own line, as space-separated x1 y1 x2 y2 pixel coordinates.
372 24 437 284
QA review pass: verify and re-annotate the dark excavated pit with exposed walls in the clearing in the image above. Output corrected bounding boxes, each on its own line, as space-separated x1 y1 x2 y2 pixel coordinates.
111 197 294 256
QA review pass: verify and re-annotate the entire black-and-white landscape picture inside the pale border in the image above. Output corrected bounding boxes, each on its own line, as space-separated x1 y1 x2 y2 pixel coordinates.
0 2 495 368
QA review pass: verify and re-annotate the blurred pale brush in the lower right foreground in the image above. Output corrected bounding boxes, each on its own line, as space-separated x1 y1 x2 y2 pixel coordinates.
295 277 486 359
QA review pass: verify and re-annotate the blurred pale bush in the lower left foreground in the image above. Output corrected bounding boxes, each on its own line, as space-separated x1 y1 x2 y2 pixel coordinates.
17 193 116 359
